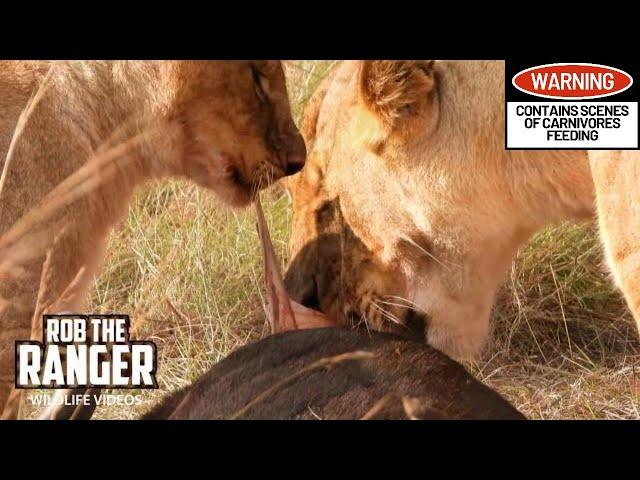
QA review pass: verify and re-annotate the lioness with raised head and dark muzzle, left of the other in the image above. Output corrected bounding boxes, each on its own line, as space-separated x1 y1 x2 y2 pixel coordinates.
0 61 306 416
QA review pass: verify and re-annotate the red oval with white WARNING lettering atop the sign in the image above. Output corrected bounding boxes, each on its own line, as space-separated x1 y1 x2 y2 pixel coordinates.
512 63 633 100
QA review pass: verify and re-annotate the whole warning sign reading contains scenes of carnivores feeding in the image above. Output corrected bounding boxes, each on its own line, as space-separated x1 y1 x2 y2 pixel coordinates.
506 64 638 149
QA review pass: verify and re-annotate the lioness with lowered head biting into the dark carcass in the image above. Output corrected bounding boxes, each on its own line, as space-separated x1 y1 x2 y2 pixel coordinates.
286 61 640 358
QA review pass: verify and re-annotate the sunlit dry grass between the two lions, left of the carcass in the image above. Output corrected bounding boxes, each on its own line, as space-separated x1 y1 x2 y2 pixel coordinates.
80 61 332 418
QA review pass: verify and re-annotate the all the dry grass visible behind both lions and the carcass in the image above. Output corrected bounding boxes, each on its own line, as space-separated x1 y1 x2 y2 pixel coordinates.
21 61 640 418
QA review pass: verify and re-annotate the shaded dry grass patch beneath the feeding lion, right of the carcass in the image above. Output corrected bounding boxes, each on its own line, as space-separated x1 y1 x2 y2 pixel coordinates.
473 224 640 419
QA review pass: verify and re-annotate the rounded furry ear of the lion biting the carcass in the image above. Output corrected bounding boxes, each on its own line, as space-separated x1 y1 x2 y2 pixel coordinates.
360 60 436 124
